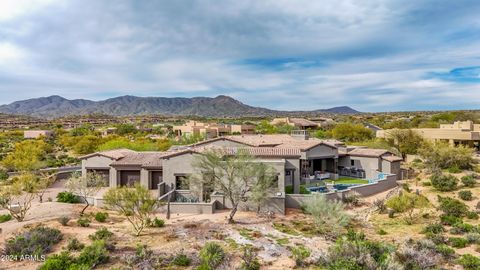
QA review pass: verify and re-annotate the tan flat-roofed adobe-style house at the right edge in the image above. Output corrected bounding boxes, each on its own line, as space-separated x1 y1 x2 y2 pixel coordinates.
377 121 480 150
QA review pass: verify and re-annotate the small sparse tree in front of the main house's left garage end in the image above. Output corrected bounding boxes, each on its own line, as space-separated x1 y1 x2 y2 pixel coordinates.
65 173 107 216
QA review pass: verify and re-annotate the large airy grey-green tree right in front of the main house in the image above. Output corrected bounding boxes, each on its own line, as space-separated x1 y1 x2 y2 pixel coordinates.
190 149 275 223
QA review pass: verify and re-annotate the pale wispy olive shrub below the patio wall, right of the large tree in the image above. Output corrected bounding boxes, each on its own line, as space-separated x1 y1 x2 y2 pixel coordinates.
305 195 350 234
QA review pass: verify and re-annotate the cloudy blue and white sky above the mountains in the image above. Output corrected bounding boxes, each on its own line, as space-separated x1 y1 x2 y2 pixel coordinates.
0 0 480 112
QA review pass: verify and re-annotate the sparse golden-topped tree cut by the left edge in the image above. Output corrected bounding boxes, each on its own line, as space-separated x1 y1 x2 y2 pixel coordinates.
0 173 38 222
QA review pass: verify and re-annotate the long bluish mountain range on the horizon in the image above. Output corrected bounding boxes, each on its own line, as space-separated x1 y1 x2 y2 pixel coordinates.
0 95 358 118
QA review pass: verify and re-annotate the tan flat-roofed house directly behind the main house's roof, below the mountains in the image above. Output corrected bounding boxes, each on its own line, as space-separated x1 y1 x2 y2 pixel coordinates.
173 121 255 139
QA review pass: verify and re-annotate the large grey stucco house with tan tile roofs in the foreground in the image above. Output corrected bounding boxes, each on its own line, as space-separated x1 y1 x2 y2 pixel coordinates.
81 131 402 213
